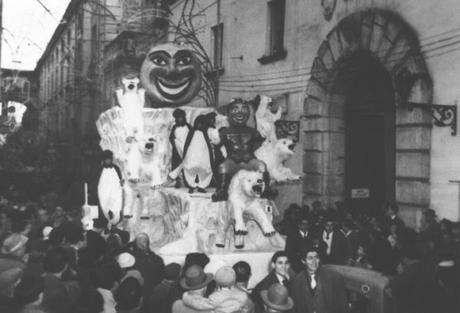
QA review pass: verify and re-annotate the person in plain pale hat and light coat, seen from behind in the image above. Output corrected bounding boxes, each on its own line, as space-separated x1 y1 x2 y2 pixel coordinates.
209 266 254 313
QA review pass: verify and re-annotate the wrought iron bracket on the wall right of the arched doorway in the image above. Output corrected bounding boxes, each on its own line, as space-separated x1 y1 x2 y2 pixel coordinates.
404 102 457 136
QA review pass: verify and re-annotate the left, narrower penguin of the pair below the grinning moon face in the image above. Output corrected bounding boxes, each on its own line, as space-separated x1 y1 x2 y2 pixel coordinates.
169 109 192 188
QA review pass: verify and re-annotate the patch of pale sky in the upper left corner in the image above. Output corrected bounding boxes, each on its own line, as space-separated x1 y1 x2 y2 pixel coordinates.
1 0 70 70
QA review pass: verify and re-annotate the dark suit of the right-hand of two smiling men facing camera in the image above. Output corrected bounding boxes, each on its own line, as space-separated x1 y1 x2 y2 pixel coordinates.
289 268 349 313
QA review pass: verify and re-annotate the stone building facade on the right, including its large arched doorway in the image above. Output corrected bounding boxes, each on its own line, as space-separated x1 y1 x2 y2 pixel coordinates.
170 0 460 227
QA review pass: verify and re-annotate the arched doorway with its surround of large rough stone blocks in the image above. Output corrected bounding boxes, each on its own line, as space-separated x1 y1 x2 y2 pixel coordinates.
303 10 432 226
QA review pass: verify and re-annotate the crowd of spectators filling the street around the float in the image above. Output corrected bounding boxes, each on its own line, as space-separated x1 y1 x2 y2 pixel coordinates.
0 191 460 313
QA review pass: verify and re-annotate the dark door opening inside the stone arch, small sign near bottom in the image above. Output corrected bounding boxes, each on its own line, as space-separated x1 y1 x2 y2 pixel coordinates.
337 52 395 213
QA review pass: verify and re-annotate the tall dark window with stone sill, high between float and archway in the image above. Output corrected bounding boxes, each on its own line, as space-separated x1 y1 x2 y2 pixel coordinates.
258 0 287 64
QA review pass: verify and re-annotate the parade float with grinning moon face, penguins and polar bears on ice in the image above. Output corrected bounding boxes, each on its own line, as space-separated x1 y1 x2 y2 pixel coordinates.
90 43 300 286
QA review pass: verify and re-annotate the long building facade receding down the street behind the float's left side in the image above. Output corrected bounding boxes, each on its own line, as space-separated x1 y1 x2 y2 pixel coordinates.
36 0 165 141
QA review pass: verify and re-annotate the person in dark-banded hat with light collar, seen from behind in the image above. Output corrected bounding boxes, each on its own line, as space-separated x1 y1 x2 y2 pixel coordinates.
172 265 215 313
